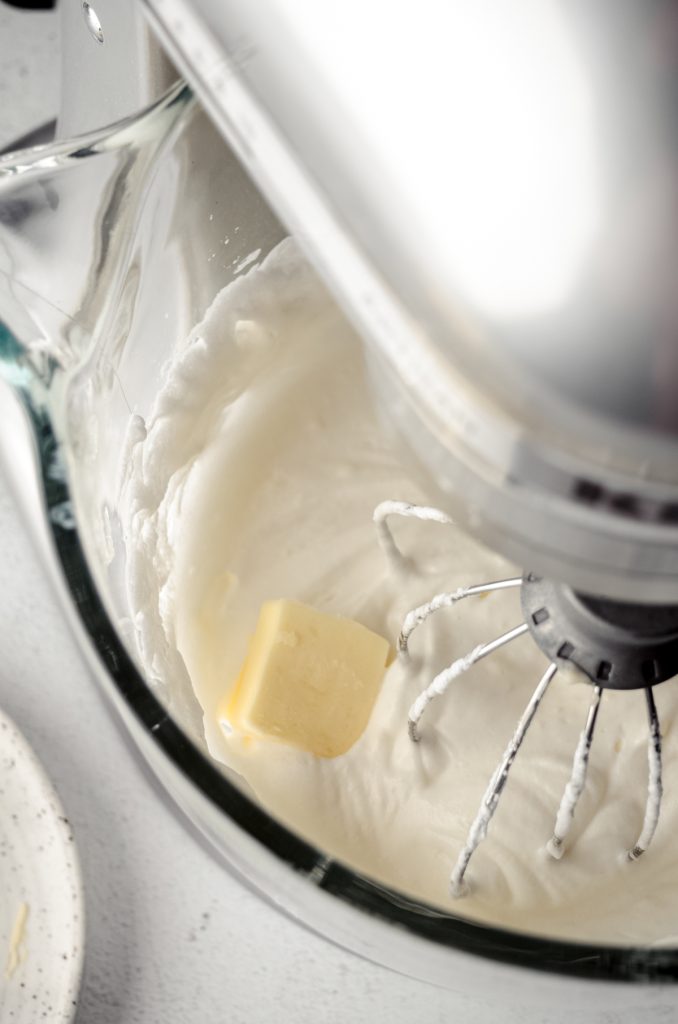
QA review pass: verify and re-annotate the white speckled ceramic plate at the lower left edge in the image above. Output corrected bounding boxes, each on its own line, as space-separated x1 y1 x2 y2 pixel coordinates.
0 711 84 1024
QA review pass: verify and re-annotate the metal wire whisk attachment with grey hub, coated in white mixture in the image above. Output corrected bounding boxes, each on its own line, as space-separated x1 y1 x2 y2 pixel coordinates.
374 501 678 897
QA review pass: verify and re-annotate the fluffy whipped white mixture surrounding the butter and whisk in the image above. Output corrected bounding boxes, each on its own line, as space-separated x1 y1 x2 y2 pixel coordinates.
125 242 678 945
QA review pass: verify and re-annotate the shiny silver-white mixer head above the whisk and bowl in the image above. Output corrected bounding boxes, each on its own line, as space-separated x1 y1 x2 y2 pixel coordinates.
137 0 678 603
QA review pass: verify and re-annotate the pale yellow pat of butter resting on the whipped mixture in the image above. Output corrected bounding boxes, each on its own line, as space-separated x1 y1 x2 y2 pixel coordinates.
219 600 391 758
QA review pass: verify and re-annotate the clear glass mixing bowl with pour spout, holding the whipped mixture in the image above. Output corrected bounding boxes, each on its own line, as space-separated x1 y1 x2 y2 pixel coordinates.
0 83 678 1024
